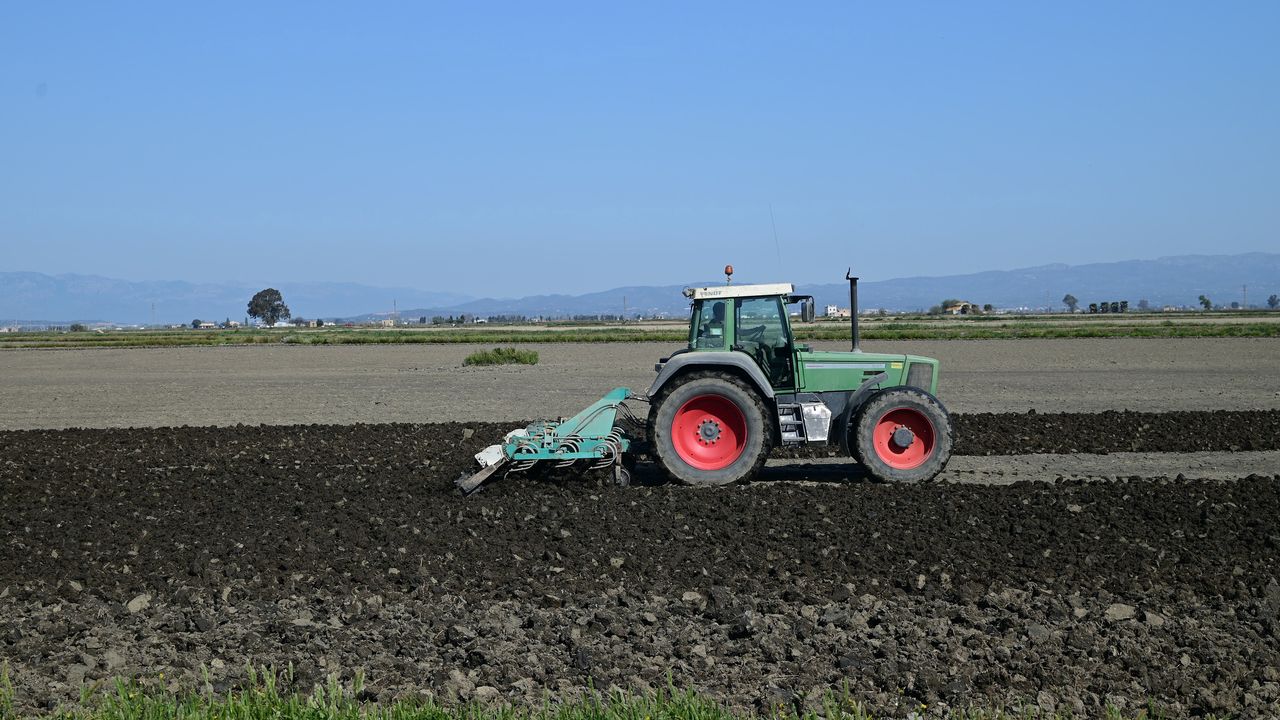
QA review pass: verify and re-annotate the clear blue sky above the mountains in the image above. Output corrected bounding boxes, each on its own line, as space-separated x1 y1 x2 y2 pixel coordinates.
0 1 1280 295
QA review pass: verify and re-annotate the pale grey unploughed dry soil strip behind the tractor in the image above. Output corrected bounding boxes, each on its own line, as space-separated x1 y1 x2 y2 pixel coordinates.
0 338 1280 429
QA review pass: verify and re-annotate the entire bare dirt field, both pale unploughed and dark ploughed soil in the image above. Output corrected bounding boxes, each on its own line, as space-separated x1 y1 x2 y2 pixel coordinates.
0 340 1280 717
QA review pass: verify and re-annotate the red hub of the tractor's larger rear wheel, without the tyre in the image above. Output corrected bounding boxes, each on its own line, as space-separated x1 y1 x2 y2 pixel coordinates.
671 395 746 470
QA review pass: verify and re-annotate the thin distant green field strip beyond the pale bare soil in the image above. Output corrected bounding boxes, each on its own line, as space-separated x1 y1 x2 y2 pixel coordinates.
0 313 1280 348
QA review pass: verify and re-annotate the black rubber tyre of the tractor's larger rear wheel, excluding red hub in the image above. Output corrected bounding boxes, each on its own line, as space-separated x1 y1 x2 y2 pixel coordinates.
649 370 773 486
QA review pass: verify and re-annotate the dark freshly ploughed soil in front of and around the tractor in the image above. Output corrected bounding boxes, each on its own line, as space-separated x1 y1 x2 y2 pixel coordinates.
0 413 1280 717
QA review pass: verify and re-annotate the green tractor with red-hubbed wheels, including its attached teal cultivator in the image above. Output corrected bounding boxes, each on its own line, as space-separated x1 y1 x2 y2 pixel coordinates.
457 266 952 493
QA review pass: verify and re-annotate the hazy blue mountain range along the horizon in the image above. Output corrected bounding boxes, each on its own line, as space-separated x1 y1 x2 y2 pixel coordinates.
0 252 1280 325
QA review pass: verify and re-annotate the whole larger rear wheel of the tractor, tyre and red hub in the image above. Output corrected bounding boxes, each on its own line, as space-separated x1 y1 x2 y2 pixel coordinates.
650 372 773 486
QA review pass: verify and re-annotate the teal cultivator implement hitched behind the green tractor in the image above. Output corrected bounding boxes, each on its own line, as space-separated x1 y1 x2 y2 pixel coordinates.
454 387 643 495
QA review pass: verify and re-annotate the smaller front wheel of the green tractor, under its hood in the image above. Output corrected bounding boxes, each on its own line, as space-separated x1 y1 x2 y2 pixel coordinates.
849 387 954 483
